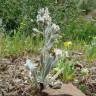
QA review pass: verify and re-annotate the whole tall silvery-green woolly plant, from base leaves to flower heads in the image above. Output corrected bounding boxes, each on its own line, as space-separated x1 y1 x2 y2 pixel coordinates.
25 7 60 86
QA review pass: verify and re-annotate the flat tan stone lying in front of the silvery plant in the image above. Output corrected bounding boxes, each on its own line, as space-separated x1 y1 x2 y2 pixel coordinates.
41 84 86 96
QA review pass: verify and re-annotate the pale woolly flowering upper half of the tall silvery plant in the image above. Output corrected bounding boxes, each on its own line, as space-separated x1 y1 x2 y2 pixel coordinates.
34 7 60 52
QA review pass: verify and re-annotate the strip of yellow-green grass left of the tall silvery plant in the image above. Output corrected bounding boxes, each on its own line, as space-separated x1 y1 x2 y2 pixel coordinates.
0 31 42 56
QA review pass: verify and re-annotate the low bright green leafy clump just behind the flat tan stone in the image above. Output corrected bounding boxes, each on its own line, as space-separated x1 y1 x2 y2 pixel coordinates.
54 51 75 83
